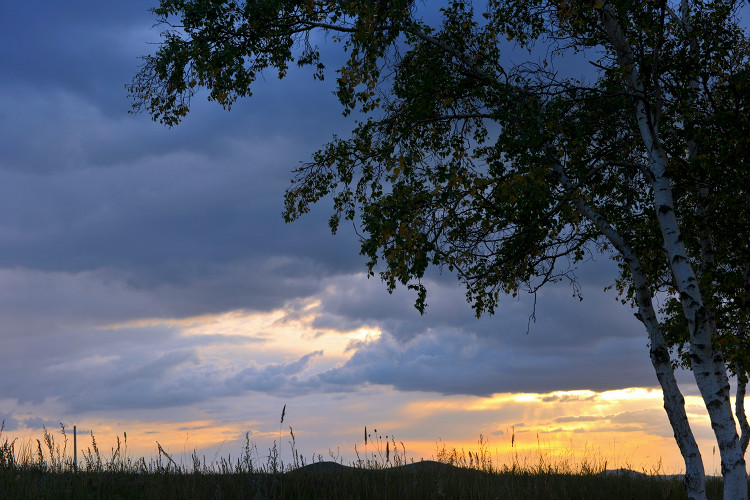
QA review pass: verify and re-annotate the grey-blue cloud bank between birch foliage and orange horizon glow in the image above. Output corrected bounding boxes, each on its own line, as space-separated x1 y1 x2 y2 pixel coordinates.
296 276 656 394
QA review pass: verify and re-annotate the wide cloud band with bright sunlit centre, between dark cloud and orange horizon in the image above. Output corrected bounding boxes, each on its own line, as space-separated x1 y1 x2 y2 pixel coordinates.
0 266 655 418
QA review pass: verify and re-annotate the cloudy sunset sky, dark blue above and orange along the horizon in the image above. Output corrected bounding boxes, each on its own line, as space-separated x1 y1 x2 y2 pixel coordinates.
0 0 732 473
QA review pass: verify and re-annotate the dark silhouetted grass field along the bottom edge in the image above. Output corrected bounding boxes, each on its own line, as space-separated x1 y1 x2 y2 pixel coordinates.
0 427 722 500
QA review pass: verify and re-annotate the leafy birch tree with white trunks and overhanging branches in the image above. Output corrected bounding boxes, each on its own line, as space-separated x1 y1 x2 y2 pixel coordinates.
128 0 750 499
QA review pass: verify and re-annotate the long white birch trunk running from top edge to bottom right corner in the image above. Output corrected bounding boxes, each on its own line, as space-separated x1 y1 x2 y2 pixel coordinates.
601 4 747 500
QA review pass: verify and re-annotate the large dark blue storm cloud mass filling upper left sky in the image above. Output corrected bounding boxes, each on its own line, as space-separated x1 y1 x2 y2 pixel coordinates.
0 2 361 315
